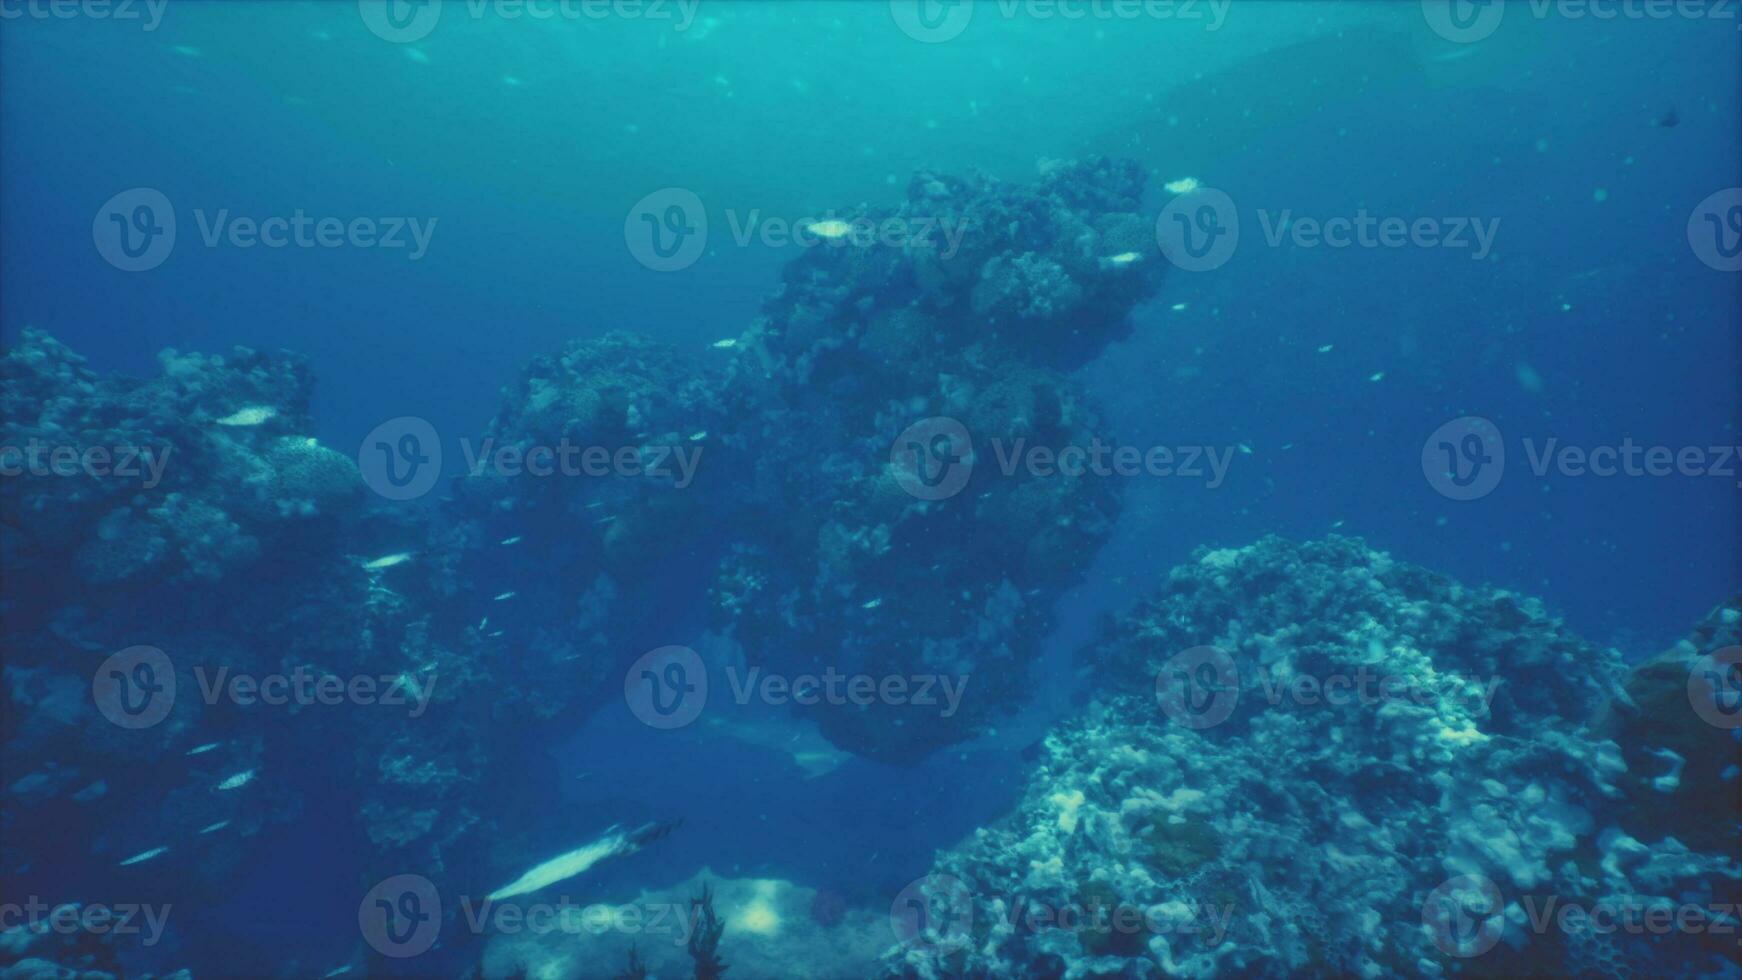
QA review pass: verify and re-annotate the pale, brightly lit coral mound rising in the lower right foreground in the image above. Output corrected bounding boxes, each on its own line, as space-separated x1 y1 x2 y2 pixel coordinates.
885 538 1742 978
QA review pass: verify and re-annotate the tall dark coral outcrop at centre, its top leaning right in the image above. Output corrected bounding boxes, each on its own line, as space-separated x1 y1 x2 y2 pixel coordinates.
714 160 1158 761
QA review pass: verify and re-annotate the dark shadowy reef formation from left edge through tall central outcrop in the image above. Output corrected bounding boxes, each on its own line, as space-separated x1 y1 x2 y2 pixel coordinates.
0 160 1158 974
